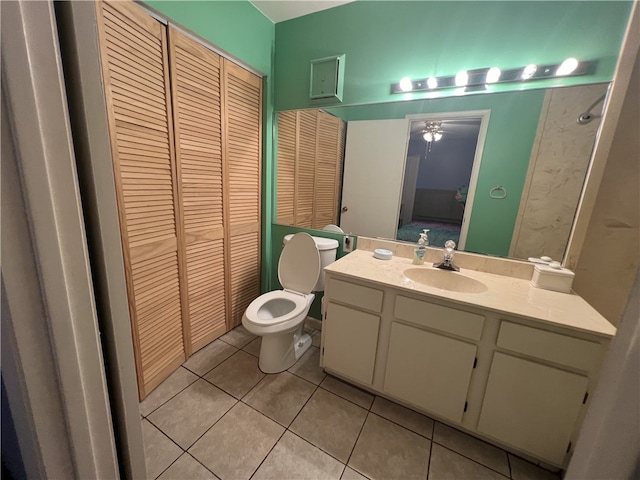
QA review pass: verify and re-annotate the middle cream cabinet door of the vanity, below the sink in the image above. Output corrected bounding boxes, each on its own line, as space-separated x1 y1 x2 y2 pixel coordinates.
384 322 476 422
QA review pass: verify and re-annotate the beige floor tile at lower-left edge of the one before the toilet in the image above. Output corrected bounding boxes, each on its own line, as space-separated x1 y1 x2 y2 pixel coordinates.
189 402 284 480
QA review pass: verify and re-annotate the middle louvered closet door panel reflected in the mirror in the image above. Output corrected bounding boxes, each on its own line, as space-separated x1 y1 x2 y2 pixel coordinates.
295 110 318 228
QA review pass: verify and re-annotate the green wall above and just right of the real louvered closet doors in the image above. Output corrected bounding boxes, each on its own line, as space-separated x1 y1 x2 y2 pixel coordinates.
145 0 275 291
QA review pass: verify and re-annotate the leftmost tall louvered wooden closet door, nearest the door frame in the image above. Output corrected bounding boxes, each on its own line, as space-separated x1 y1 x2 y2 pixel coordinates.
97 1 185 399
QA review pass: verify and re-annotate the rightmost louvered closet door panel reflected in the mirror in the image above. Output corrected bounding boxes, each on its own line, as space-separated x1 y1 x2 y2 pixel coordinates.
312 112 343 229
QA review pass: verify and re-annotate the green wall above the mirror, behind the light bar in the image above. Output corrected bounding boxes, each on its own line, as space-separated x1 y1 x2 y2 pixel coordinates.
275 1 631 110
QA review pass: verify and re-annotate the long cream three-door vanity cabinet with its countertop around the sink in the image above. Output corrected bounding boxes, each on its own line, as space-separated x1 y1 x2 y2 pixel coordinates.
320 252 615 468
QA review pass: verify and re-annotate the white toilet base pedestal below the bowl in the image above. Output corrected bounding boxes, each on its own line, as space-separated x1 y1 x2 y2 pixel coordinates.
258 322 312 373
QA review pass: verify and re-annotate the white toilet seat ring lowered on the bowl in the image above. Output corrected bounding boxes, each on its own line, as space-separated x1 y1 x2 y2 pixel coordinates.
244 290 309 327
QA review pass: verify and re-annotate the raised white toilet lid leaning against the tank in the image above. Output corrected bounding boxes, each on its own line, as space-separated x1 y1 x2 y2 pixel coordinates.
278 232 320 294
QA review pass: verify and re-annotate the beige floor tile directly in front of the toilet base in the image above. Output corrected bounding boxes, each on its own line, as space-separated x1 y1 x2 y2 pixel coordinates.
242 372 316 427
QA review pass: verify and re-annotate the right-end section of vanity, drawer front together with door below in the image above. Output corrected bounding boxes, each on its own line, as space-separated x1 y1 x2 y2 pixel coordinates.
478 321 601 464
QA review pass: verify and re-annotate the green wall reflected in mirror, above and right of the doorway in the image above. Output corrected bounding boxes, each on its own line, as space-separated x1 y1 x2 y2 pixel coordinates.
327 90 545 256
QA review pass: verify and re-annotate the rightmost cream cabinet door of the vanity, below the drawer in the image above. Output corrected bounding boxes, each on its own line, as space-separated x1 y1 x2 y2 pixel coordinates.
478 353 587 465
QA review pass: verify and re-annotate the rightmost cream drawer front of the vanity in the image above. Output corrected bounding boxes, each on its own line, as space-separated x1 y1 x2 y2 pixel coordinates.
497 321 601 371
